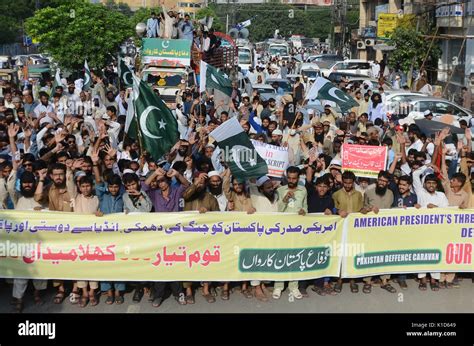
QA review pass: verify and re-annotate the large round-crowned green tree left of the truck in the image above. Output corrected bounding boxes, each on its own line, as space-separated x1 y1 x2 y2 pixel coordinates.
25 1 134 70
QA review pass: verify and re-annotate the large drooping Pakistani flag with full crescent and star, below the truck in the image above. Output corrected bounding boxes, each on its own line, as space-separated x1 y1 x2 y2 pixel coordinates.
128 76 179 160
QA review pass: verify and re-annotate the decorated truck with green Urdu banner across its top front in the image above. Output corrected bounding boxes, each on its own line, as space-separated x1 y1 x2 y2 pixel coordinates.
139 38 195 108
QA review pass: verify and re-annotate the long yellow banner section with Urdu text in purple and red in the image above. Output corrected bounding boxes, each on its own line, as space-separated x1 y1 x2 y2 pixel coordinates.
0 211 343 281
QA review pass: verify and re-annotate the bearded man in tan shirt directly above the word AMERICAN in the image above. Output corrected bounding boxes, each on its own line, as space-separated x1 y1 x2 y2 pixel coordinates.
361 171 397 293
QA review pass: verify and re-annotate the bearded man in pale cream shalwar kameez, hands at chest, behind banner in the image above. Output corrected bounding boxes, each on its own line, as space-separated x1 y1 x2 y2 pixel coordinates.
272 166 308 299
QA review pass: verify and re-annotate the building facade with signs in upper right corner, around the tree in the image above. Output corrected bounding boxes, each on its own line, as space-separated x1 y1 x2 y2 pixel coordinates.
358 0 474 95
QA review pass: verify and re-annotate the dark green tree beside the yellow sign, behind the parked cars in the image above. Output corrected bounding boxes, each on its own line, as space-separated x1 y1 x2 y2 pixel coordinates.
388 25 441 72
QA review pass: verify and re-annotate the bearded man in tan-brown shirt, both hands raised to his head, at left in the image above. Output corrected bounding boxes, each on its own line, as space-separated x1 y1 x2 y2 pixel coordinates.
34 162 78 304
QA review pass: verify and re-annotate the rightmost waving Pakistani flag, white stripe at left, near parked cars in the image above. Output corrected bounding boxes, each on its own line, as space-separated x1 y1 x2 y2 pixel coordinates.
306 77 359 111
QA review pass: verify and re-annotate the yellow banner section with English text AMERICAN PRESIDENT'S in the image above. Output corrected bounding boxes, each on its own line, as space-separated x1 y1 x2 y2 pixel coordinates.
342 208 474 277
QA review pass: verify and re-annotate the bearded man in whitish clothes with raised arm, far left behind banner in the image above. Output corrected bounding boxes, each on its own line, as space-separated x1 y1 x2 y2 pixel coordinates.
8 168 48 313
